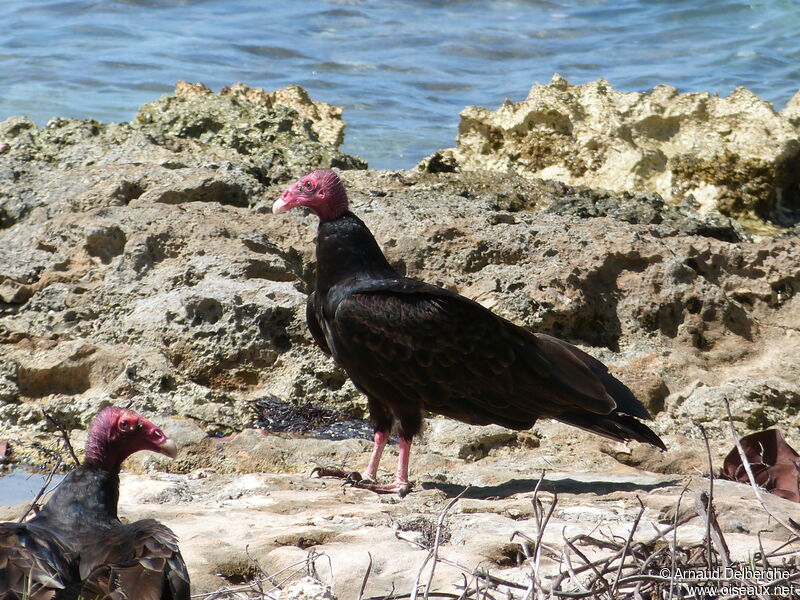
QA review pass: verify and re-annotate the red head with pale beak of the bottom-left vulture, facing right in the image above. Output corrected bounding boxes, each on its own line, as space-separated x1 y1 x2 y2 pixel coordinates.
84 406 178 471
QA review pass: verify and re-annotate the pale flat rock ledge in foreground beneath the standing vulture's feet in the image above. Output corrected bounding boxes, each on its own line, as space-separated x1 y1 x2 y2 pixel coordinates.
0 449 796 598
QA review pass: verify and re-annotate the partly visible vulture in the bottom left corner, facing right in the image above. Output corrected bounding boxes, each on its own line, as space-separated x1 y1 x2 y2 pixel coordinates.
0 407 189 600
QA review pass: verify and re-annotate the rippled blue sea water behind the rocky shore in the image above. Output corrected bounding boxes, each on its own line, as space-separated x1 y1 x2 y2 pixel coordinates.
0 0 800 168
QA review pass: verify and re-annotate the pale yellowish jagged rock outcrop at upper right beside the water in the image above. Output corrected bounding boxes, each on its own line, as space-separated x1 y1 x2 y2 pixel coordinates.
420 75 800 225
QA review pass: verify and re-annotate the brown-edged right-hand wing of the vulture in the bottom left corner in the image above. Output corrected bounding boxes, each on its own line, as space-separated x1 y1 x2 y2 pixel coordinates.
80 519 189 600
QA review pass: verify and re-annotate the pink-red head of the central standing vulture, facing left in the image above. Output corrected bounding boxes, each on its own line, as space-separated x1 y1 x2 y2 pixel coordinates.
272 169 347 223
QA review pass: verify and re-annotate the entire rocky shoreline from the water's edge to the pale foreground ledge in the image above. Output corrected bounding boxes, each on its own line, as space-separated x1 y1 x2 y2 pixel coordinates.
0 78 800 598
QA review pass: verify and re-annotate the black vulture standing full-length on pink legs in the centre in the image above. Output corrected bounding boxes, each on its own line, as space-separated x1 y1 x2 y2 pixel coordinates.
272 170 666 496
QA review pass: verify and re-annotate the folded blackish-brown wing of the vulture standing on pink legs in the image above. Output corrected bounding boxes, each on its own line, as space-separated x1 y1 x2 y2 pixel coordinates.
333 280 615 428
